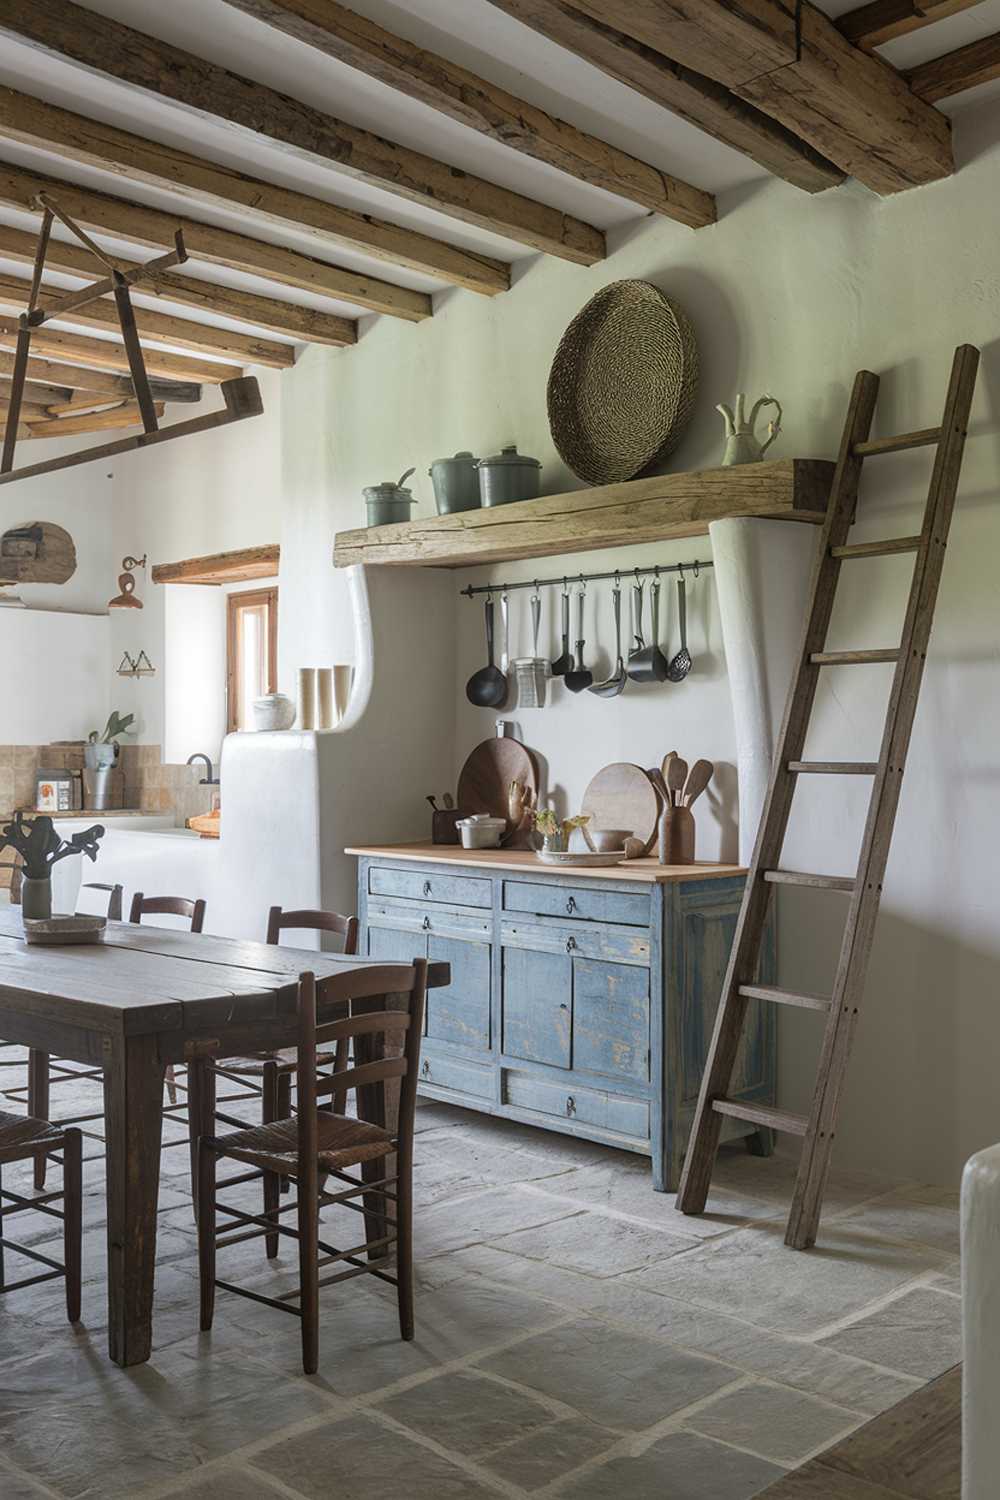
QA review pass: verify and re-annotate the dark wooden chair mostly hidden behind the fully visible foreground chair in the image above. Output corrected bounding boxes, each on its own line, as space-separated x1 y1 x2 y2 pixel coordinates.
206 906 358 1230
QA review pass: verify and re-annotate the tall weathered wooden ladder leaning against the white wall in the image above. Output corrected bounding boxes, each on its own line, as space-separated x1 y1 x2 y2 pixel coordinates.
678 344 979 1250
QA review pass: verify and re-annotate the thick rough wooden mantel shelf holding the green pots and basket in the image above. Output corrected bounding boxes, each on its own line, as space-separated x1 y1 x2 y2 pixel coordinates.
333 459 834 567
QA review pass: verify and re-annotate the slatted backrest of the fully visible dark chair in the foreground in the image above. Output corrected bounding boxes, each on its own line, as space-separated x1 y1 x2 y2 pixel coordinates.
297 959 427 1181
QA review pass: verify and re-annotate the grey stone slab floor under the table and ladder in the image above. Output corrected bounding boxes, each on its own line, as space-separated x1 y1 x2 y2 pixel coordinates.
0 1055 960 1500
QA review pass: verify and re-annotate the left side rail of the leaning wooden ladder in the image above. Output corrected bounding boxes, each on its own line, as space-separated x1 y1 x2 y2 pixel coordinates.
676 371 879 1214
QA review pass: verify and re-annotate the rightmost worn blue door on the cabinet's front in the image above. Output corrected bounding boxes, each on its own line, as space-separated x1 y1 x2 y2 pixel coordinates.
573 959 649 1083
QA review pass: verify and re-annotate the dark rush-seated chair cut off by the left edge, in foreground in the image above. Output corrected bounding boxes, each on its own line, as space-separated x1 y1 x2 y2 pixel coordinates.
0 1112 84 1323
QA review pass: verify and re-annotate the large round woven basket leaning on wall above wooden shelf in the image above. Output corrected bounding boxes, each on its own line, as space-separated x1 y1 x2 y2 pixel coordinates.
547 281 699 485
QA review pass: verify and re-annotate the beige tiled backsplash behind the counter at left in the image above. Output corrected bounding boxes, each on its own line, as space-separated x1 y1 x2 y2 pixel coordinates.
0 743 219 888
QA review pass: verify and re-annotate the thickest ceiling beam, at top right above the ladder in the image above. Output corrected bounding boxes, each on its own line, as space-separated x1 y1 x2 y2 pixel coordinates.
563 0 955 194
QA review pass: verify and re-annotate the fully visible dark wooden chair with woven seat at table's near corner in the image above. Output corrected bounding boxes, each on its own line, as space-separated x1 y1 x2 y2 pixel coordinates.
198 959 427 1376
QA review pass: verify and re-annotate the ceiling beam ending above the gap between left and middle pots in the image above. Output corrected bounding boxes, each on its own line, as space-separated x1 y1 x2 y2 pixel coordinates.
0 162 433 323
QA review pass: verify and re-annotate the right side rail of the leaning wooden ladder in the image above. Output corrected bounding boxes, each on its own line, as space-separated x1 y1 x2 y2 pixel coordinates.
786 345 979 1250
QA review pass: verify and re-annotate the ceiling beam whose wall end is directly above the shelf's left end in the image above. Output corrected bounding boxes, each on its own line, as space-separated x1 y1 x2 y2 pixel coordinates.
0 224 357 347
